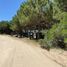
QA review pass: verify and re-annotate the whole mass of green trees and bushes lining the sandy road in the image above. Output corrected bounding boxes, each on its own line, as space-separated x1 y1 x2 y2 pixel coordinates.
0 0 67 48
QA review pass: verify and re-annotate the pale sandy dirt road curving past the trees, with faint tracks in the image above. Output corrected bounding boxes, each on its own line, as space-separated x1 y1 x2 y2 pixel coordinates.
0 35 62 67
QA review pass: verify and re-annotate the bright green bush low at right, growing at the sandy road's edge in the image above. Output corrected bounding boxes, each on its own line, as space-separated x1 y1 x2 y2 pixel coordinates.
41 22 67 49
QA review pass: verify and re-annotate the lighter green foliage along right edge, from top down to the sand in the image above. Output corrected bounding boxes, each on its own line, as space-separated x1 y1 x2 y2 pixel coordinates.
39 0 67 49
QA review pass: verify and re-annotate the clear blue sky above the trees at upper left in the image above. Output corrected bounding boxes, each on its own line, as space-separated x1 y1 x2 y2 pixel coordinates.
0 0 25 21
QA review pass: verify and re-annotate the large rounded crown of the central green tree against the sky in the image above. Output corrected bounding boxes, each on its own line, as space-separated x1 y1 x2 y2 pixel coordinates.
17 0 53 27
